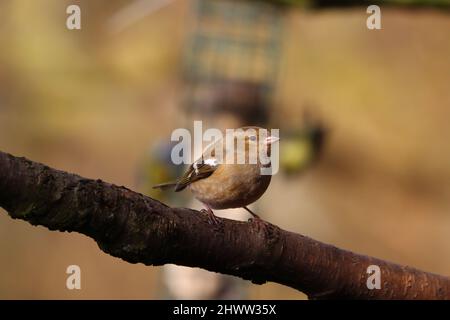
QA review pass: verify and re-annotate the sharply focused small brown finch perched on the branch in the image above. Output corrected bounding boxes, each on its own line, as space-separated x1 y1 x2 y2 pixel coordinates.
153 126 279 224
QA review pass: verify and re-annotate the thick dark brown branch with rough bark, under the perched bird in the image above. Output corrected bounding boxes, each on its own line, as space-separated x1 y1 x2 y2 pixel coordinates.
0 152 450 299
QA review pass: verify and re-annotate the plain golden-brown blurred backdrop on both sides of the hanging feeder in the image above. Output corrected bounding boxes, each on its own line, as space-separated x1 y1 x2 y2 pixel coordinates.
0 0 450 299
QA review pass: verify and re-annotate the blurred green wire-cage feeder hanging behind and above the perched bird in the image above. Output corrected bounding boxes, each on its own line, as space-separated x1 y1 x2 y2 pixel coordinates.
183 0 283 125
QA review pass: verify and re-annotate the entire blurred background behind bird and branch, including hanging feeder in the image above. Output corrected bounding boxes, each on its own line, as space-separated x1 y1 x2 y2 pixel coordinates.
0 0 450 299
